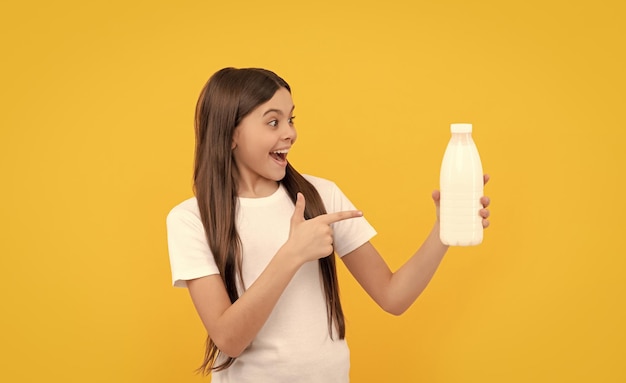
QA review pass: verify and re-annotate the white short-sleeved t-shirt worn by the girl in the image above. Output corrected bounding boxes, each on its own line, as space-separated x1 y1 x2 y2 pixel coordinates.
167 176 376 383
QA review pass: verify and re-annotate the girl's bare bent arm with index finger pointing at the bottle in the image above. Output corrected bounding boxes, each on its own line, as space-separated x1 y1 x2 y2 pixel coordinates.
187 194 362 357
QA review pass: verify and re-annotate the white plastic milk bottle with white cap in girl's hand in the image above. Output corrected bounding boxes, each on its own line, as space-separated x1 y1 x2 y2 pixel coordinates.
439 124 484 246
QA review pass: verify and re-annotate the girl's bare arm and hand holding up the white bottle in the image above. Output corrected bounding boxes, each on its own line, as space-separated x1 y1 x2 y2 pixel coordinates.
342 175 490 315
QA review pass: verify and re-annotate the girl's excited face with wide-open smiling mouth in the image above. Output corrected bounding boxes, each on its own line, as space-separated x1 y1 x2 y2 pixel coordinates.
232 88 297 196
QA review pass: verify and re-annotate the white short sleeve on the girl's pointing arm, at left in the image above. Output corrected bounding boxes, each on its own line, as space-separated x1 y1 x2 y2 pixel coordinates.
166 199 219 287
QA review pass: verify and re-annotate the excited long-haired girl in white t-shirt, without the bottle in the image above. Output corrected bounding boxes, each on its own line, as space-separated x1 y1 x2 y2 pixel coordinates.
167 68 489 383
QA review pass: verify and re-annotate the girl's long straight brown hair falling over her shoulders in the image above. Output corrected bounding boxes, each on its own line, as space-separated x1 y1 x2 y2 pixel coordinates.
194 68 345 375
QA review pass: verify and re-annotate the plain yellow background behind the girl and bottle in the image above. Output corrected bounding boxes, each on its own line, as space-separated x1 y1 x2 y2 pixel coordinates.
0 0 626 382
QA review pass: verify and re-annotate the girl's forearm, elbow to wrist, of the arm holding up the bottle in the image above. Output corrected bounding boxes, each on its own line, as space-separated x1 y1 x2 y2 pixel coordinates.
385 222 448 315
